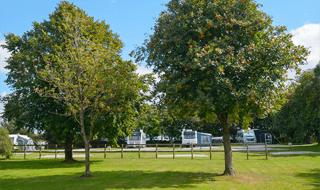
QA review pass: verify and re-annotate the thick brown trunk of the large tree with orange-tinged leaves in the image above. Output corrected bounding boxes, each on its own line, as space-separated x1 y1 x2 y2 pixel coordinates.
218 113 236 176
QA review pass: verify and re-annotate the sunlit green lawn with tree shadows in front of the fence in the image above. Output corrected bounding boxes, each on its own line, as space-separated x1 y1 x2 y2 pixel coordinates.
0 145 320 190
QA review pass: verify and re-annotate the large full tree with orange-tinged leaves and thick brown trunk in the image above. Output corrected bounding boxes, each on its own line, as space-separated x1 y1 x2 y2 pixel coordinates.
134 0 308 175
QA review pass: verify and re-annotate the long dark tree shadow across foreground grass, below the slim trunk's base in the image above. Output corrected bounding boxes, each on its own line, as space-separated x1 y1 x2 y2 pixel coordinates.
1 170 221 190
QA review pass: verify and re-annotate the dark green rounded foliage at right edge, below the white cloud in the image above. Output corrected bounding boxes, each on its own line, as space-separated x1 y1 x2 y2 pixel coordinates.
270 63 320 143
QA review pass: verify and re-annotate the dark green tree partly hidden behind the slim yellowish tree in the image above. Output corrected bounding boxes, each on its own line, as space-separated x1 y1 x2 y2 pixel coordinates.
1 6 84 162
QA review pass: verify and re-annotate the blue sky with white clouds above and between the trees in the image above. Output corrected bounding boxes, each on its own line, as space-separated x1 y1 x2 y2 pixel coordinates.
0 0 320 113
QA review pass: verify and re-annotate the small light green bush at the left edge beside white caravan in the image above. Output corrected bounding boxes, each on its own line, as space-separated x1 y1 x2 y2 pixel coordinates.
0 127 13 158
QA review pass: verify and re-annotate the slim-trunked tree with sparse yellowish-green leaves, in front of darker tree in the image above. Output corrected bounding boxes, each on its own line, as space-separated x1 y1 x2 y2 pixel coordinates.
34 1 148 176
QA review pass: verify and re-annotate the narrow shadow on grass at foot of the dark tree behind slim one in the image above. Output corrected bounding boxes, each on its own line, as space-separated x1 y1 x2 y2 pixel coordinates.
0 159 103 170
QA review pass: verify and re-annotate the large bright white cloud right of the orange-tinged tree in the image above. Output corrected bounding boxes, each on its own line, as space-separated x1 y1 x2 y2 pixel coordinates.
290 24 320 70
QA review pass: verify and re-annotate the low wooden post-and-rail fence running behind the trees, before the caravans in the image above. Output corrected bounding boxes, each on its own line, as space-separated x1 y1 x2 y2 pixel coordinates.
14 143 268 160
